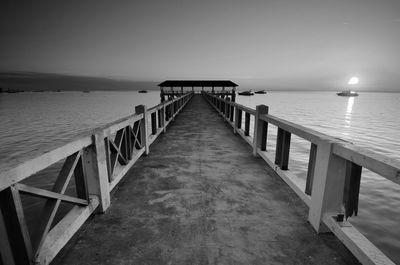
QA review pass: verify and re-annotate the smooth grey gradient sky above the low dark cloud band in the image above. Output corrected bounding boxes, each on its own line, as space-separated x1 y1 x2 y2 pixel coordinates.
0 0 400 91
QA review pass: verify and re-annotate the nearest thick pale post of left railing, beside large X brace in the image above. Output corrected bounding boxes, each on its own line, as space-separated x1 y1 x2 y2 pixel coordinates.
82 132 110 213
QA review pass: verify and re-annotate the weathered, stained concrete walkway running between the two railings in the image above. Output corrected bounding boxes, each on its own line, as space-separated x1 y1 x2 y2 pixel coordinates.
55 96 357 265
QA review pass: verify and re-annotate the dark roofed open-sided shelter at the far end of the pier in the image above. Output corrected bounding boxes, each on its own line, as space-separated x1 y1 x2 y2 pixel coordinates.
158 80 238 102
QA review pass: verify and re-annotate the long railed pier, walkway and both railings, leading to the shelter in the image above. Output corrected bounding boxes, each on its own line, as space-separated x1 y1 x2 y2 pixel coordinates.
0 88 400 264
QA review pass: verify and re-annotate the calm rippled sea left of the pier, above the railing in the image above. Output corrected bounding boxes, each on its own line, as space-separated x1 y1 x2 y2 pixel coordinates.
0 91 160 169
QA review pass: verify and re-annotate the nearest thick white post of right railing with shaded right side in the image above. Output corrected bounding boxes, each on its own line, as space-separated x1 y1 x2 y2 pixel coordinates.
308 140 346 233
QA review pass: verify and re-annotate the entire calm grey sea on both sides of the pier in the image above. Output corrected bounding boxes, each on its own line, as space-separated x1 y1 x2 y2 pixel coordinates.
0 91 400 264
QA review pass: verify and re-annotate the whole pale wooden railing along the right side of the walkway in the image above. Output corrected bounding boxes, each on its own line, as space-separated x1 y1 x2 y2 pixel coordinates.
203 92 400 264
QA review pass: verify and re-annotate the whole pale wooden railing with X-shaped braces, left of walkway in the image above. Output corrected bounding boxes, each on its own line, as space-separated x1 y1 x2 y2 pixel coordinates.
0 93 193 265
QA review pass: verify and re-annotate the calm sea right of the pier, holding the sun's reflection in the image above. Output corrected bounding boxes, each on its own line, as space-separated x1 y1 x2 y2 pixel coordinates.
236 92 400 264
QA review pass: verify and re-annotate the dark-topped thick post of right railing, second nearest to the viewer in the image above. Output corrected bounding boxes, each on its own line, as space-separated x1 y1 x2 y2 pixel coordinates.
253 105 268 156
